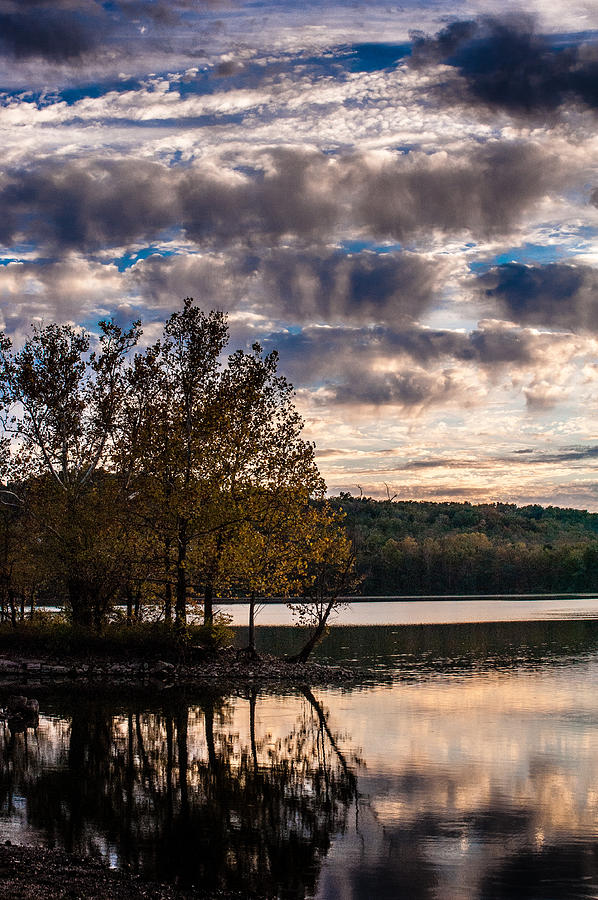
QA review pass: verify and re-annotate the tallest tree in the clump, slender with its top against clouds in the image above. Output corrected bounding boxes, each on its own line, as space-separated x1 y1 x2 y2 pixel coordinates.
119 297 227 627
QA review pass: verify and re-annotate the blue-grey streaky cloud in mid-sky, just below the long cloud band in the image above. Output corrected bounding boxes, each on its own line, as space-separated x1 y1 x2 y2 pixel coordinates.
261 251 441 322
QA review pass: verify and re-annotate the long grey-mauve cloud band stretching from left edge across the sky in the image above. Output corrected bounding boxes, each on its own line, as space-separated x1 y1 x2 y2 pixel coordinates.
0 142 559 253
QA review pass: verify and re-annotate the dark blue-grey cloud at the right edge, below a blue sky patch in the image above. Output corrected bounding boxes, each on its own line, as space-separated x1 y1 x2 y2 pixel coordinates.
478 262 598 331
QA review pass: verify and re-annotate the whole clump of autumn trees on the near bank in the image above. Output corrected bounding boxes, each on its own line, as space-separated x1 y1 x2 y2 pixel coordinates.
0 299 354 661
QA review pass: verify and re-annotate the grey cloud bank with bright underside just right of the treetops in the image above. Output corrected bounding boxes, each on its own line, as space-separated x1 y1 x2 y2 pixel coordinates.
264 324 549 407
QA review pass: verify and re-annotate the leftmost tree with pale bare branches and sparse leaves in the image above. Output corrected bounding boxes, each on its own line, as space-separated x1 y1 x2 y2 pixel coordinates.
0 321 141 628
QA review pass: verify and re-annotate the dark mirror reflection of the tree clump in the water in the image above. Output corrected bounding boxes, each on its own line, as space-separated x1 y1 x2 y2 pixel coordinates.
0 690 359 898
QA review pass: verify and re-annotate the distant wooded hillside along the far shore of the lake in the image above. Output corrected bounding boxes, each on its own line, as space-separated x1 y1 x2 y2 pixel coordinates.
333 494 598 594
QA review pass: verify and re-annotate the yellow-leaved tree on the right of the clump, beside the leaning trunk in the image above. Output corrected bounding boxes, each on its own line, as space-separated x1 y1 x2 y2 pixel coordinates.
199 344 325 628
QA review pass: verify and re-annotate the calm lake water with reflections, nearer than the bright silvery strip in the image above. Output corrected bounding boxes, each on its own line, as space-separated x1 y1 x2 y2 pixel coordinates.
0 618 598 900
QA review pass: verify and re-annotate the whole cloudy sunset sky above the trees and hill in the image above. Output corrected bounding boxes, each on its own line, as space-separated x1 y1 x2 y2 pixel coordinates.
0 0 598 510
